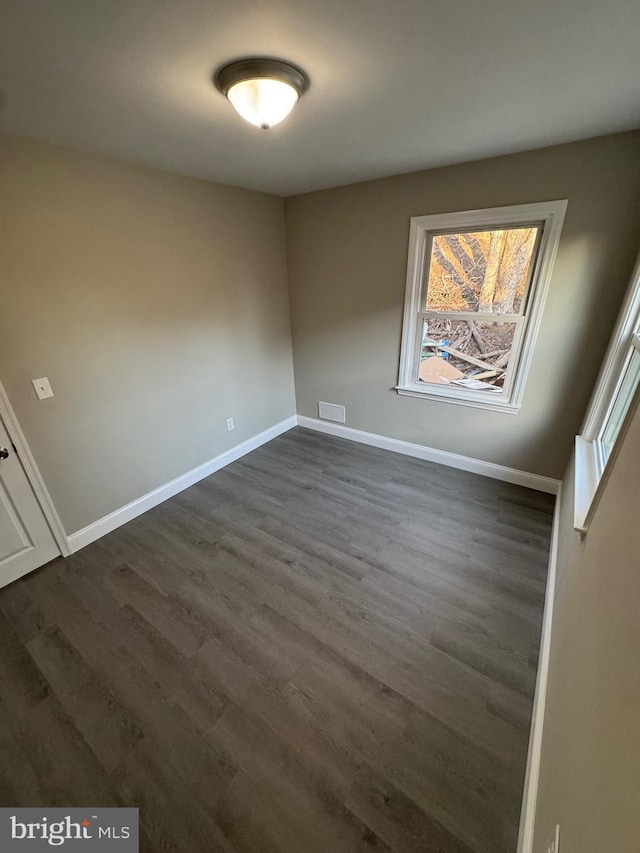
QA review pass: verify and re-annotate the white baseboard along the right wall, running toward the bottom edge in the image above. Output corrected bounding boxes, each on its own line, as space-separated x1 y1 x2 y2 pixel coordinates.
517 485 562 853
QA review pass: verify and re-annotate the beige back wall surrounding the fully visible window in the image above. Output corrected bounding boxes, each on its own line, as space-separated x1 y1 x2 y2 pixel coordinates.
286 133 640 477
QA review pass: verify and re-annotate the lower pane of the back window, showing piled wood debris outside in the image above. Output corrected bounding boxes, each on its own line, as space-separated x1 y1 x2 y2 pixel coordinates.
418 318 516 394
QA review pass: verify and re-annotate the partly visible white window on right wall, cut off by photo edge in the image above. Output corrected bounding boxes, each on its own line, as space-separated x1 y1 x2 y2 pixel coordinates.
574 250 640 534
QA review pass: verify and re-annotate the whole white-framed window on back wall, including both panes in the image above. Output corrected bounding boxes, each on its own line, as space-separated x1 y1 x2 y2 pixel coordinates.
397 201 567 412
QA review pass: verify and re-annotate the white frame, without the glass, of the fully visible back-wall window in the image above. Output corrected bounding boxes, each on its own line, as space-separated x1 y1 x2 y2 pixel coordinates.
396 199 567 414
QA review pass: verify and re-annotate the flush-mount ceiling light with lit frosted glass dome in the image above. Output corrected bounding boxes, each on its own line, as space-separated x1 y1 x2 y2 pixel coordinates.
213 57 309 130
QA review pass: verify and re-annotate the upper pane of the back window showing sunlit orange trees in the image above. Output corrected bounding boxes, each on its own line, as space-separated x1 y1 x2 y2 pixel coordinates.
425 226 540 314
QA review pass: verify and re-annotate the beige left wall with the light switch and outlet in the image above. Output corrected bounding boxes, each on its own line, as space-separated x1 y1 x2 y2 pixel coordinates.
0 139 295 533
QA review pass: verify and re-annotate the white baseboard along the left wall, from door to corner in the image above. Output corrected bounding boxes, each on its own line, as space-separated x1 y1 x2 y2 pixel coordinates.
69 415 297 553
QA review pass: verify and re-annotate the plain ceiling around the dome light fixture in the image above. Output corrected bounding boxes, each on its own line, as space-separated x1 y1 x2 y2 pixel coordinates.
0 0 640 195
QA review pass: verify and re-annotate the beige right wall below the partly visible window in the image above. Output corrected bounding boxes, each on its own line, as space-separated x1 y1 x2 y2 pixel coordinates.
534 402 640 853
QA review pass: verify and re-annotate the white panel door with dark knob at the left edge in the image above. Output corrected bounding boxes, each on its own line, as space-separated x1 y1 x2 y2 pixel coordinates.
0 421 60 586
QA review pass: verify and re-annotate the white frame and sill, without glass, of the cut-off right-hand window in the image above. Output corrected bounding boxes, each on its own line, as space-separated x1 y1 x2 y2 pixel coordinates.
573 250 640 536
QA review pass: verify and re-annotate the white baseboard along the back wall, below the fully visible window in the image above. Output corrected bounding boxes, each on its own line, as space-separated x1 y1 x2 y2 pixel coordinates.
298 415 560 495
